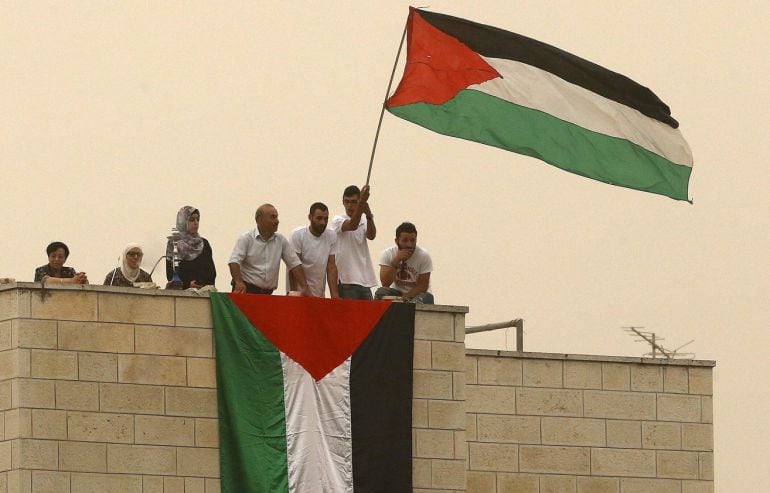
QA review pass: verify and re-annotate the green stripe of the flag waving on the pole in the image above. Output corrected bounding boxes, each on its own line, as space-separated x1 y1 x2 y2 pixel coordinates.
388 89 692 200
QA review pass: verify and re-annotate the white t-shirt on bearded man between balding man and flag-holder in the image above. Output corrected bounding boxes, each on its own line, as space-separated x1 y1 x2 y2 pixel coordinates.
286 226 337 298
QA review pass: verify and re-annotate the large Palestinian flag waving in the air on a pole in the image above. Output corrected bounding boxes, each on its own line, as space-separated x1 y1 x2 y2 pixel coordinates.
385 8 692 200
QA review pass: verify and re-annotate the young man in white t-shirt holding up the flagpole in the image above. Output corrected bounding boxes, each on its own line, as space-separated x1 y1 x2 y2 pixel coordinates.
332 185 377 300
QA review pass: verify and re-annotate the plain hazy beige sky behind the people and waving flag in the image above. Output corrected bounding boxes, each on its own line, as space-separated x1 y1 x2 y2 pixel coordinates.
0 0 770 491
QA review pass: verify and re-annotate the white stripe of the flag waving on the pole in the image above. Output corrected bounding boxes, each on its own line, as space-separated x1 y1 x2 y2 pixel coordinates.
468 57 692 167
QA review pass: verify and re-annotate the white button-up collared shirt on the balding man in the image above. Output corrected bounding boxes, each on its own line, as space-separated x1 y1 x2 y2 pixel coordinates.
228 228 301 289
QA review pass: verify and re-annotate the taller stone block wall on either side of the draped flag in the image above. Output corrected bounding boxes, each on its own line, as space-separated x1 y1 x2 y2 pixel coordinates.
0 283 467 493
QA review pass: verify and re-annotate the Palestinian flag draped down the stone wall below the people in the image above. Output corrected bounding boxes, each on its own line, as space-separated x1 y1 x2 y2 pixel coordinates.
211 293 414 493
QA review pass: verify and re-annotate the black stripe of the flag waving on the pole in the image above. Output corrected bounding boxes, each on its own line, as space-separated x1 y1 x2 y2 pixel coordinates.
416 10 679 128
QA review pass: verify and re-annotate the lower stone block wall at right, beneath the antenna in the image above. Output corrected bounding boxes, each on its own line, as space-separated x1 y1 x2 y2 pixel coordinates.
465 350 714 493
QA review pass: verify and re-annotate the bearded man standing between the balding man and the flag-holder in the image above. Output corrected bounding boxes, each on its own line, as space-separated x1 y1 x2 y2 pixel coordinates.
286 202 340 298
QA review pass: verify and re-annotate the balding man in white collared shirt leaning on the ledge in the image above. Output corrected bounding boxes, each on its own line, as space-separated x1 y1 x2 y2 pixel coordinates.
228 204 308 295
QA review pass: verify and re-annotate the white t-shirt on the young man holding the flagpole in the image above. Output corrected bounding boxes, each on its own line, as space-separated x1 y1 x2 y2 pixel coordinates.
331 214 377 288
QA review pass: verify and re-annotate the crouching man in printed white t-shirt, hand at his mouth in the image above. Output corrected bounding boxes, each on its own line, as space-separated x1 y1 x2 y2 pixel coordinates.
375 223 433 305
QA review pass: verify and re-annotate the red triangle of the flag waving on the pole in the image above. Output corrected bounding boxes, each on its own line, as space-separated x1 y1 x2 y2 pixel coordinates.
385 8 501 107
